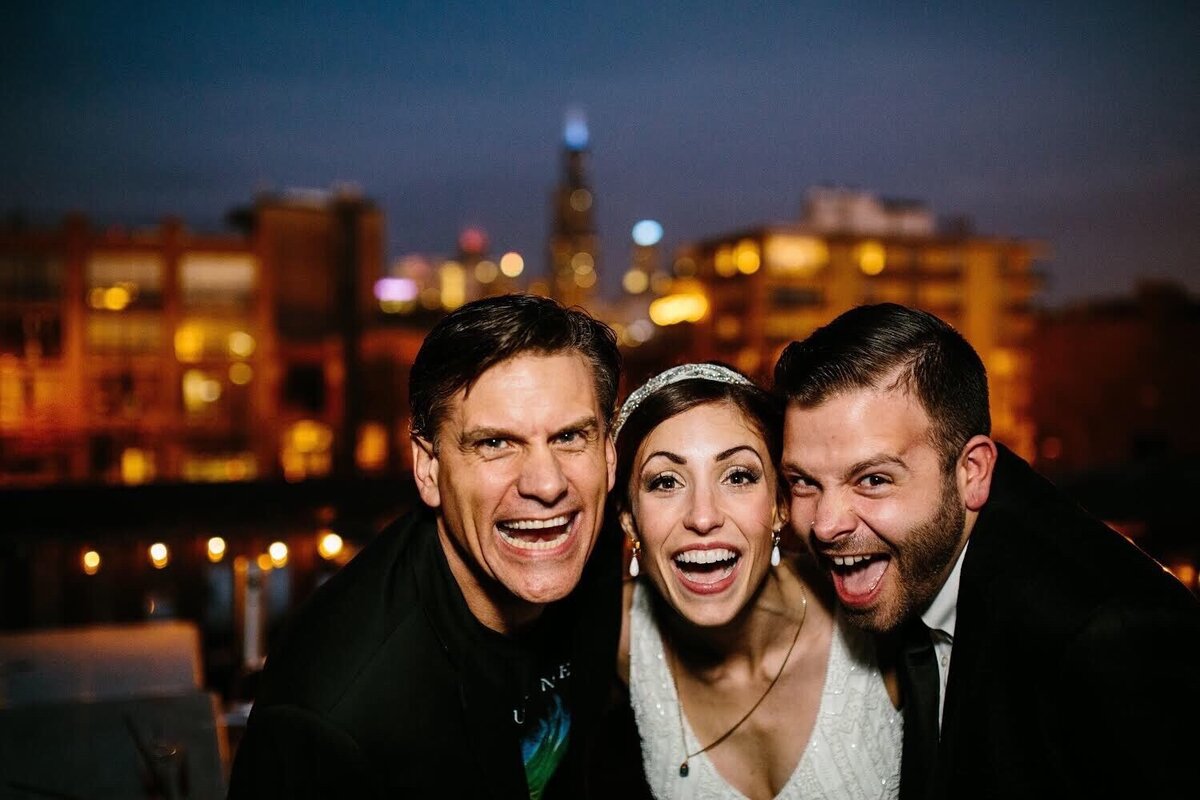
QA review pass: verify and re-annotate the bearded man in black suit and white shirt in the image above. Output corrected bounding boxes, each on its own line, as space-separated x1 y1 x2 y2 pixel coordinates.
775 305 1200 800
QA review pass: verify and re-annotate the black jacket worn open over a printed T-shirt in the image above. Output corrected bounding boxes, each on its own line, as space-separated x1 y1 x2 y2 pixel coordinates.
229 511 620 799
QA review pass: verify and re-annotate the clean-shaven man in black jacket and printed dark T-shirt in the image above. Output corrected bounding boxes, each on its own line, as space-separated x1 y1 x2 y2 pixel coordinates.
230 295 620 798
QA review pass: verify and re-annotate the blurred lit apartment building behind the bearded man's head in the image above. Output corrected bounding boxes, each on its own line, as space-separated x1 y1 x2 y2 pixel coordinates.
674 188 1038 456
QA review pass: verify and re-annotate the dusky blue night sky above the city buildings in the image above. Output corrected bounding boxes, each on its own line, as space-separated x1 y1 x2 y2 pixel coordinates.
0 0 1200 305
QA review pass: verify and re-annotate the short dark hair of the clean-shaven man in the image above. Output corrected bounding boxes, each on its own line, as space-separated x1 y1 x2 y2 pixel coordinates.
408 294 620 441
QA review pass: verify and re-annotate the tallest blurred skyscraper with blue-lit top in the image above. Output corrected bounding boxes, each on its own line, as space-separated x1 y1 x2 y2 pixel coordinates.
550 112 598 306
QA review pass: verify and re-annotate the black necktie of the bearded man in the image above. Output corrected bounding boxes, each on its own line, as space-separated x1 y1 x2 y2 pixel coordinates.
898 618 941 800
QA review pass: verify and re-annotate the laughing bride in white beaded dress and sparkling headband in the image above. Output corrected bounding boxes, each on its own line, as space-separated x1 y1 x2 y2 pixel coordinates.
614 363 902 800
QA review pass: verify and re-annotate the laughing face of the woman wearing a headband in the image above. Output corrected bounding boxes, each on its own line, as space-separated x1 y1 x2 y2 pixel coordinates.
622 402 781 626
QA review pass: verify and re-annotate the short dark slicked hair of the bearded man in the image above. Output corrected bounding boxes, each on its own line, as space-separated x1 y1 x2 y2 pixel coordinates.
775 303 991 469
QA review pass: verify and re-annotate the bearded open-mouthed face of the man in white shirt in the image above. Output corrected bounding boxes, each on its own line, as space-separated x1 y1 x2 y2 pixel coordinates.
782 389 969 632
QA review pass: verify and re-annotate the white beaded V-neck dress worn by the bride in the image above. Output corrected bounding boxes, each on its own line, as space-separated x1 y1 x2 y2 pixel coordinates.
629 583 904 800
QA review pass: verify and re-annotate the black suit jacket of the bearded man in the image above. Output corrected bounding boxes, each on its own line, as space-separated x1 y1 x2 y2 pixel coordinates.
931 447 1200 799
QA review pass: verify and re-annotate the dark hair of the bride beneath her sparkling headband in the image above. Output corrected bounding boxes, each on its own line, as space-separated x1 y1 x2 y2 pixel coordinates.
612 365 784 511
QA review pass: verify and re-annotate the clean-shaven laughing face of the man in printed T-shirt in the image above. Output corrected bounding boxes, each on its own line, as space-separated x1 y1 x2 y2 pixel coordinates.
413 353 614 631
